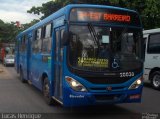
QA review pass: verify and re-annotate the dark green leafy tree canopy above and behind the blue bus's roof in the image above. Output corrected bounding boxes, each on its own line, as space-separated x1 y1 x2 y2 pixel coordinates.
28 0 160 29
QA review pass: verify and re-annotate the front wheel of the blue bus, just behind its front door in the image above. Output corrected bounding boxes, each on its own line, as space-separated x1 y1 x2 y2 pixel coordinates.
43 77 53 105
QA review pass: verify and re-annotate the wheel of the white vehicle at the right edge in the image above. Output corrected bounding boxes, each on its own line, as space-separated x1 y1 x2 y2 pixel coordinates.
151 71 160 90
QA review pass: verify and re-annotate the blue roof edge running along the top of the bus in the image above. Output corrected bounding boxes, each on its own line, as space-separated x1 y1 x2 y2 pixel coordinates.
17 4 137 37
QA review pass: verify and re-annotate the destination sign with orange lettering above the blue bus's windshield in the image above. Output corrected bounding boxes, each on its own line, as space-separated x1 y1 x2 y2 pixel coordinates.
70 8 141 27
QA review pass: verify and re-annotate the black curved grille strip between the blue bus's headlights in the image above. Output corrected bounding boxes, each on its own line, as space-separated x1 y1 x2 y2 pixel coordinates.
84 77 130 84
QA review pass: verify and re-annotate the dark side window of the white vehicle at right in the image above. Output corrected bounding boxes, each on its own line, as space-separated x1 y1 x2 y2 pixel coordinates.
148 33 160 53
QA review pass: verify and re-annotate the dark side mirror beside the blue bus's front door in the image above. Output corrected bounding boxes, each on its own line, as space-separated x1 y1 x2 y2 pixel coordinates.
61 30 70 46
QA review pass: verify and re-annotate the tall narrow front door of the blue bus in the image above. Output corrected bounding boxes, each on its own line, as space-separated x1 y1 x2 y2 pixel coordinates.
54 27 64 101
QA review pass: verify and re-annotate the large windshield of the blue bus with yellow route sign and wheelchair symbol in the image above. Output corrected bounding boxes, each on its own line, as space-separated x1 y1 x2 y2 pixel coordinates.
69 24 142 71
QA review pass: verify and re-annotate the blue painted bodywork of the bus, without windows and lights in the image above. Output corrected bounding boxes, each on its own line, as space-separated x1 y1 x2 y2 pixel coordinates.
16 4 143 106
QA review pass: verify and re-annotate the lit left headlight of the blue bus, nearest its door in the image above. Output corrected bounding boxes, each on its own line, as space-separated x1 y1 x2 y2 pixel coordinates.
65 76 87 92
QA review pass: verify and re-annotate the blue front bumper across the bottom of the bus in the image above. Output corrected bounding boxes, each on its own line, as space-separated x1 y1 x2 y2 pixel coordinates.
63 86 143 107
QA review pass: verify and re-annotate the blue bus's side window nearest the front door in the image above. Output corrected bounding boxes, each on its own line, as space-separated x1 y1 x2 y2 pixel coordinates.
42 23 53 53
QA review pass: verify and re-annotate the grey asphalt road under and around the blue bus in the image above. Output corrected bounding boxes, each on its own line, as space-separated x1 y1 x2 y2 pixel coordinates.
0 65 160 119
